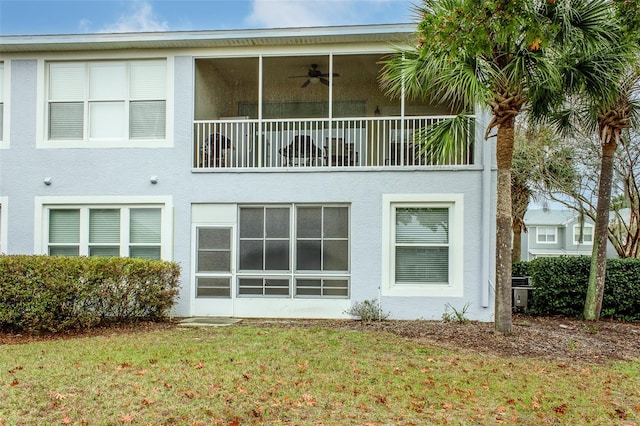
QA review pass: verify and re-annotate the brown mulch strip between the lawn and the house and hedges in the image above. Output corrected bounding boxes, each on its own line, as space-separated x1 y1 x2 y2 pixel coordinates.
0 315 640 363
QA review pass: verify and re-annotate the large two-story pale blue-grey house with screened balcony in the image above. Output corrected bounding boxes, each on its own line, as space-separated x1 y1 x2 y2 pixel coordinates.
0 25 495 320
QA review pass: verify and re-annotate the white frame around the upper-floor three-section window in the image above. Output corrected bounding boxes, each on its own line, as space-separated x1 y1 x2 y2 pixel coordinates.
36 56 174 149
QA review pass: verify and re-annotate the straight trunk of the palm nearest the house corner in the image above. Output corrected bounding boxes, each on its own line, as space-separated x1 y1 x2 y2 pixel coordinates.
495 117 515 334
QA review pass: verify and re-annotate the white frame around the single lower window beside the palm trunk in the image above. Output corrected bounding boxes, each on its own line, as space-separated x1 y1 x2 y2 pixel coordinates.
381 194 464 297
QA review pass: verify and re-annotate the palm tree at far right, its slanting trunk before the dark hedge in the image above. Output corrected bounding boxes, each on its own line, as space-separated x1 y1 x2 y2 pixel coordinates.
538 0 640 321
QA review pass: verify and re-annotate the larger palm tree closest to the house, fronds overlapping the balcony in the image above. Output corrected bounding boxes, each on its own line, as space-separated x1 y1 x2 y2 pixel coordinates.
382 0 616 334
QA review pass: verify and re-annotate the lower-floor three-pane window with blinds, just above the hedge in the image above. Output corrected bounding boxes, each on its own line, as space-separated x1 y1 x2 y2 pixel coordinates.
46 206 162 259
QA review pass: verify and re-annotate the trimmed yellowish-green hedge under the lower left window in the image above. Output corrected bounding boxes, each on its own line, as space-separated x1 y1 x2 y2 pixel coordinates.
0 255 180 333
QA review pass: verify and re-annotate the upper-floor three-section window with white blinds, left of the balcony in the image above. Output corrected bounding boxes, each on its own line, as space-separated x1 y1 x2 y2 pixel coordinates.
47 60 167 142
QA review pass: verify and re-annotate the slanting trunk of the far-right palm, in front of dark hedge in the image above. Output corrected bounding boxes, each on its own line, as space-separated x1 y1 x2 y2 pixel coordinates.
584 139 617 321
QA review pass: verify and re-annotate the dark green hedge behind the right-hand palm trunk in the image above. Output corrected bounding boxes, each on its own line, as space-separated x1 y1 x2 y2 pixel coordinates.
528 256 640 320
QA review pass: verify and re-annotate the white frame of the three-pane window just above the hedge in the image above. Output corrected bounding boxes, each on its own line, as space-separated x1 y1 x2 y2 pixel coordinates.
34 196 173 260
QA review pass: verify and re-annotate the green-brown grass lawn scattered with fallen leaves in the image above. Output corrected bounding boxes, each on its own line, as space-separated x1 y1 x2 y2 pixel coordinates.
0 326 640 426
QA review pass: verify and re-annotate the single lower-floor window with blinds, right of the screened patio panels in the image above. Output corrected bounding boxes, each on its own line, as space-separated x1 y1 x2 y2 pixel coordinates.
394 207 449 284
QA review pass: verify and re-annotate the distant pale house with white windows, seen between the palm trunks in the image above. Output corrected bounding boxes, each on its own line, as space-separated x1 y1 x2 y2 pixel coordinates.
521 209 594 260
